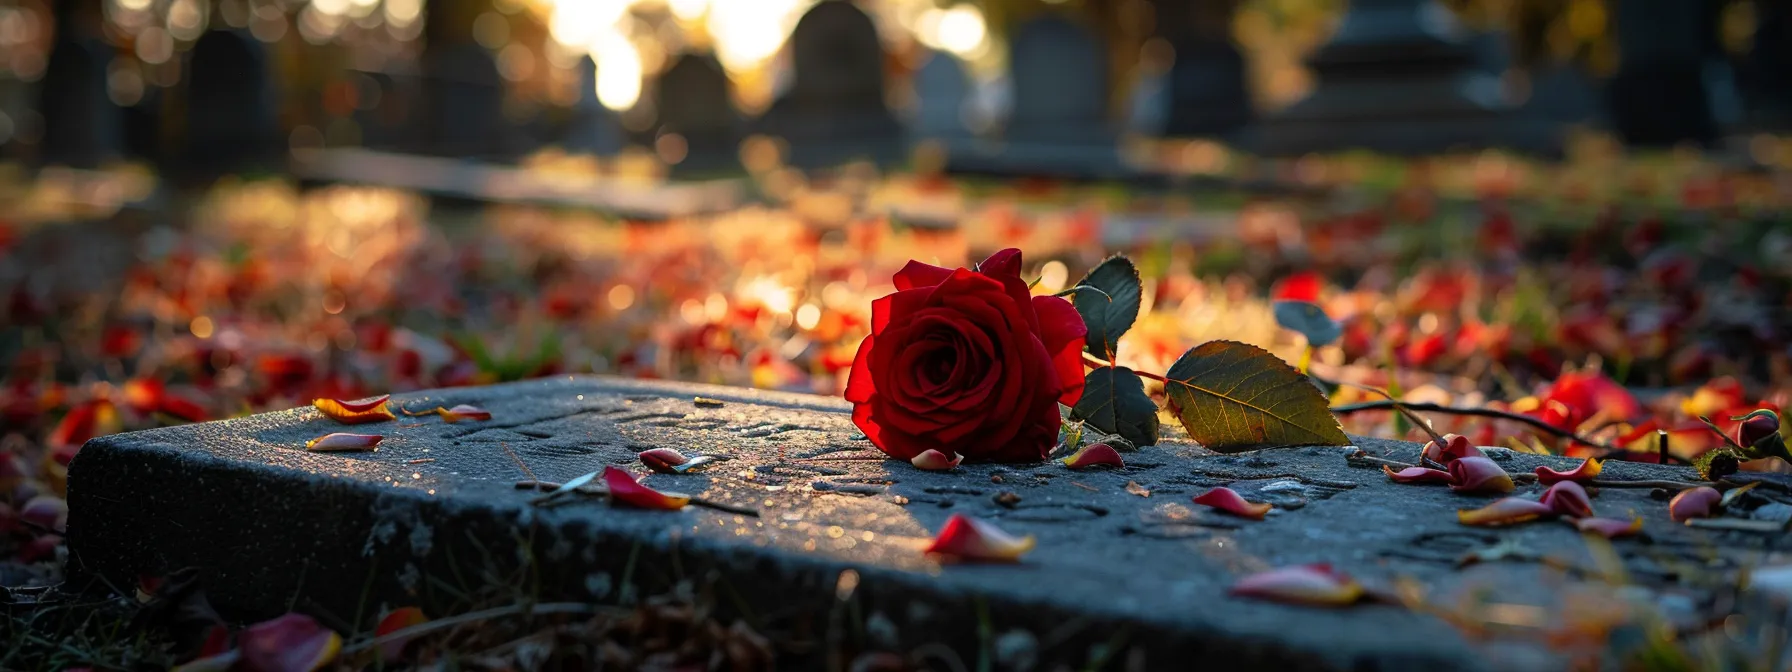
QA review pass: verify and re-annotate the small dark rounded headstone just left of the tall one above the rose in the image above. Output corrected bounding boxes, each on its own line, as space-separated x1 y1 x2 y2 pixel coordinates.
654 54 740 174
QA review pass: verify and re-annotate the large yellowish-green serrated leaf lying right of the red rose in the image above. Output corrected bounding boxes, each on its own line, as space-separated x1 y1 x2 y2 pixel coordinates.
1163 340 1349 453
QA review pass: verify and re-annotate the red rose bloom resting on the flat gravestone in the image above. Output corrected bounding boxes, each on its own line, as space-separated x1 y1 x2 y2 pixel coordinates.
846 249 1088 462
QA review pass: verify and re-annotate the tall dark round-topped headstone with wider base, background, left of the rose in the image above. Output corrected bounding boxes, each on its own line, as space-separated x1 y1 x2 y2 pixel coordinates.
760 0 903 167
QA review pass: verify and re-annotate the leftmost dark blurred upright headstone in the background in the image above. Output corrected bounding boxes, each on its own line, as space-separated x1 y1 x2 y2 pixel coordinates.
38 0 124 168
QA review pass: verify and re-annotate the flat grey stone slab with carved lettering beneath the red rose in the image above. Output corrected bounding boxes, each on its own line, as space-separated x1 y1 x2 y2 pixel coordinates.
68 376 1792 670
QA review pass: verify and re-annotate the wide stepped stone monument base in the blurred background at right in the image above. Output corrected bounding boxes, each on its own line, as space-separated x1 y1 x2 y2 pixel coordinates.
1249 0 1561 154
